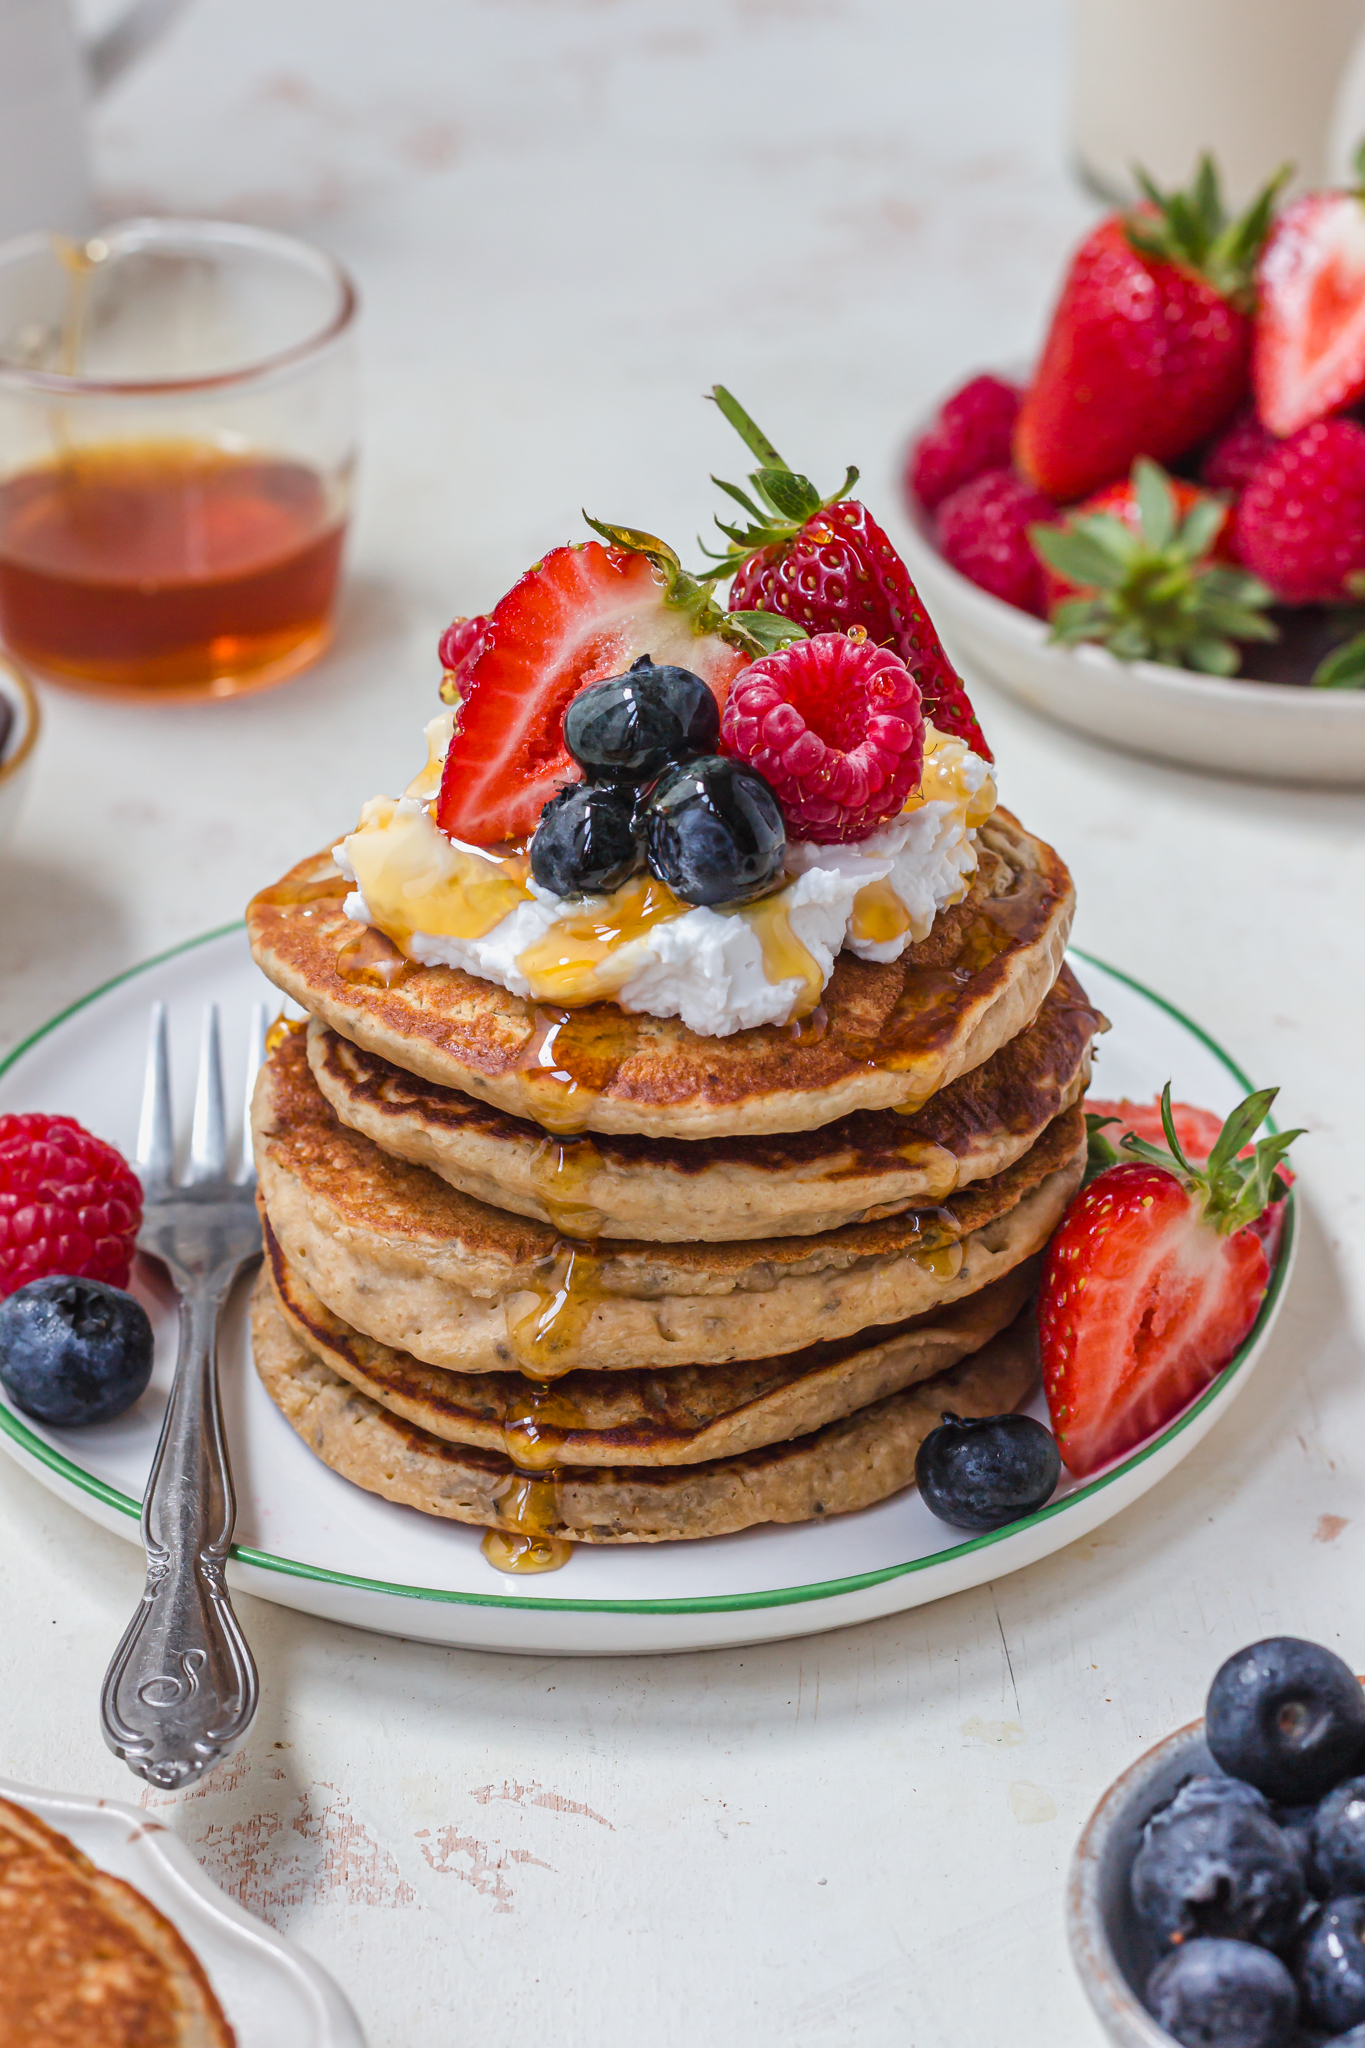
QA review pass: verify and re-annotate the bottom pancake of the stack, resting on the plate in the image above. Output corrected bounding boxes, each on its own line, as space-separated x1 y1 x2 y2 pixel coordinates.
252 1274 1038 1544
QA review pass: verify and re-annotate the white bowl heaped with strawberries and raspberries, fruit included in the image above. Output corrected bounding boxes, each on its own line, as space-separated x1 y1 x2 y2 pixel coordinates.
905 147 1365 786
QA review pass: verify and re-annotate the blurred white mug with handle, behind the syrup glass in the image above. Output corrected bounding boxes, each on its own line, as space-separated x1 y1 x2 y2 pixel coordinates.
0 0 184 242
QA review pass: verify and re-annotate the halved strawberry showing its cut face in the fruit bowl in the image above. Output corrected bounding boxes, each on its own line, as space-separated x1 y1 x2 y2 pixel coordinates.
1252 184 1365 436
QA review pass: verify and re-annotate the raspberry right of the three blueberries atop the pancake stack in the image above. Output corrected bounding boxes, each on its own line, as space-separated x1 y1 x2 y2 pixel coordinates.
720 633 925 846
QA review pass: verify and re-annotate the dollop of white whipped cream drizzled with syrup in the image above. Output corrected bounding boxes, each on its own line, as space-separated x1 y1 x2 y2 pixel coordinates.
334 715 995 1038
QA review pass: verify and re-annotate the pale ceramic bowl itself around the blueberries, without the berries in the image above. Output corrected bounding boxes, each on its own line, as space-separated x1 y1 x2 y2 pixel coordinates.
1066 1679 1365 2048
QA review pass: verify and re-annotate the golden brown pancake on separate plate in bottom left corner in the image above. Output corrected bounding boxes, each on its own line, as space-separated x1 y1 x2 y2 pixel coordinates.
0 1800 235 2048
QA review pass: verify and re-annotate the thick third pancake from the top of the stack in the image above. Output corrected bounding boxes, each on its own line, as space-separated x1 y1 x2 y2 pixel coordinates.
252 1034 1085 1378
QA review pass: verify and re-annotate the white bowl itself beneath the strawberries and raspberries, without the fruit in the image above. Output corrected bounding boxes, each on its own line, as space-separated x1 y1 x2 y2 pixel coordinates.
902 391 1365 788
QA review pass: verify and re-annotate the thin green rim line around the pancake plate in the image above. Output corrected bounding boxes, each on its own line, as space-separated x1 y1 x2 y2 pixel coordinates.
0 924 1295 1614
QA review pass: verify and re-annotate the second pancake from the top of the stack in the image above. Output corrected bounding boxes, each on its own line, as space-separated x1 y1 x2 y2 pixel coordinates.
307 967 1105 1243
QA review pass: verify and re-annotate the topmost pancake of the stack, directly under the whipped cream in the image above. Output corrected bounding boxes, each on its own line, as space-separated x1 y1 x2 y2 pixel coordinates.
248 811 1074 1139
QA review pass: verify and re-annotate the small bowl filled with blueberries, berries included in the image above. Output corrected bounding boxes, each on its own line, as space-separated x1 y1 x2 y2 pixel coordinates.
1066 1636 1365 2048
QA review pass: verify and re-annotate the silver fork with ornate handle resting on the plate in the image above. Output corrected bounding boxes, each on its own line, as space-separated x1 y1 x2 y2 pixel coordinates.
100 1004 266 1790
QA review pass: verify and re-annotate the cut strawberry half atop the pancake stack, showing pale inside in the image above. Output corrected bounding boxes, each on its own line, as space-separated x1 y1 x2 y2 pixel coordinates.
436 526 751 846
